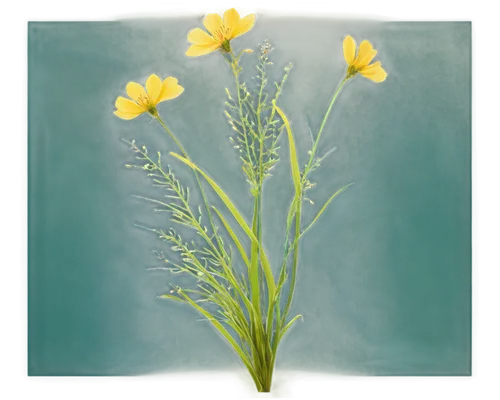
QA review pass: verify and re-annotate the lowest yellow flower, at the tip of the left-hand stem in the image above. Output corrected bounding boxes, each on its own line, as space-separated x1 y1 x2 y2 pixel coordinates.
113 74 184 119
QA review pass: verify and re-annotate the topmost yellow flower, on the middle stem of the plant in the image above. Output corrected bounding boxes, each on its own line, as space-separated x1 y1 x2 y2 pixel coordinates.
185 7 255 57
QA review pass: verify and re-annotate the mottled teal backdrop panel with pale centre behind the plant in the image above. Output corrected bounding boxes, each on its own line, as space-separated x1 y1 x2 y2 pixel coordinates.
22 12 476 379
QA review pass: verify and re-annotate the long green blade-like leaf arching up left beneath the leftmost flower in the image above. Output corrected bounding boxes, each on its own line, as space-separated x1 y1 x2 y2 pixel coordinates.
170 152 276 298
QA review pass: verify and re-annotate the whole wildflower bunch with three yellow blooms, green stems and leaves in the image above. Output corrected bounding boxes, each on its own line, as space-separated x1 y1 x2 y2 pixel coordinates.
114 7 387 398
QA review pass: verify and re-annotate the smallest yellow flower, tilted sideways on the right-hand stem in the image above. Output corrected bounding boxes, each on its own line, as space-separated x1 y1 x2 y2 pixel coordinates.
342 35 387 83
